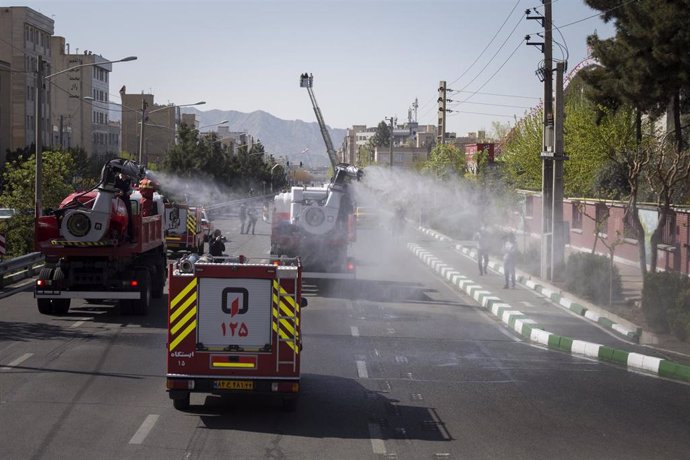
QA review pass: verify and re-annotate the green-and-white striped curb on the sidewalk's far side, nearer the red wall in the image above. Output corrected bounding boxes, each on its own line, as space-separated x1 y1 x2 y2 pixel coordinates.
419 227 642 343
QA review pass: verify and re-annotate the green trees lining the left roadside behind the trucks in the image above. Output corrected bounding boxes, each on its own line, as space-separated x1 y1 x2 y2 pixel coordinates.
0 125 286 257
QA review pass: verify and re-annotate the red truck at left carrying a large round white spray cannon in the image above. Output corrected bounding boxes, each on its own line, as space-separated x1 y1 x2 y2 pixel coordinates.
34 158 167 315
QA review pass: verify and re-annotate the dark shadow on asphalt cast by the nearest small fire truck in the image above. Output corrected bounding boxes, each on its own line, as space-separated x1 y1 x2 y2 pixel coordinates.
190 374 453 441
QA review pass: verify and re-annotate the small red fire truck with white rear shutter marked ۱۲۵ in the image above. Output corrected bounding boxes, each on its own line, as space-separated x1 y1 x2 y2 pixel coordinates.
167 254 306 410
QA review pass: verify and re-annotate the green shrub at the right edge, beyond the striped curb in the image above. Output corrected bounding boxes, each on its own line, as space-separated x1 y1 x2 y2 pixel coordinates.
642 272 690 332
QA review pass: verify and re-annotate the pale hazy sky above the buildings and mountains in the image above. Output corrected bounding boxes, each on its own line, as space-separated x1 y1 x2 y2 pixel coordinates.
17 0 613 135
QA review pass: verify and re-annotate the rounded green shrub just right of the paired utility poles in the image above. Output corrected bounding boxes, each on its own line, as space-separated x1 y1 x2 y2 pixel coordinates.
565 253 623 304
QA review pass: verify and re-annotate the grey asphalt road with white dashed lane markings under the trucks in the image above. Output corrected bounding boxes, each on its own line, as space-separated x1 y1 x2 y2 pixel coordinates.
0 214 690 459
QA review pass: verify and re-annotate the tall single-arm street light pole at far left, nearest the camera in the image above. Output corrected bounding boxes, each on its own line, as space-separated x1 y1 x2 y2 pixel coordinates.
34 55 137 218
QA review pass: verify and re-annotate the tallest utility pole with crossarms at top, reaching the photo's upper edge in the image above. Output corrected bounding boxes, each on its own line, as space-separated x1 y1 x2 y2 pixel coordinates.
526 0 554 280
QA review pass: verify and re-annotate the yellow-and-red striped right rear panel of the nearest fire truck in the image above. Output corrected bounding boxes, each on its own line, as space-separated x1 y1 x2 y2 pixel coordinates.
276 266 300 372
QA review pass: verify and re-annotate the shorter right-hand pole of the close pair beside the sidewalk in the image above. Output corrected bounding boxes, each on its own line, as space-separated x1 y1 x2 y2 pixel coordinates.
551 61 568 280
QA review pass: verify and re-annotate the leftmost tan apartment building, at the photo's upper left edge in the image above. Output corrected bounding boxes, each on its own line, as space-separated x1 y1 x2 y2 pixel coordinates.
0 6 54 165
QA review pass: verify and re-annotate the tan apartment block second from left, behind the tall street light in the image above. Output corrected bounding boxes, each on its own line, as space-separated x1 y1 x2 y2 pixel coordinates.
47 36 120 157
